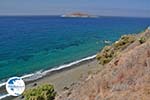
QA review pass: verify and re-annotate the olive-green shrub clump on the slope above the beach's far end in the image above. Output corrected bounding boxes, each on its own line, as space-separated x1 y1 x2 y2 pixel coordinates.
96 35 136 65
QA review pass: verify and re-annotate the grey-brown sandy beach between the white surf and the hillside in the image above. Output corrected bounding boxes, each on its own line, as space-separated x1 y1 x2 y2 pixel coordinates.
2 58 102 100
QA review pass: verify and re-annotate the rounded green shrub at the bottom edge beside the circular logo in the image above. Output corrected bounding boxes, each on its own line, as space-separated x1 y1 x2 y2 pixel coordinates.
23 84 56 100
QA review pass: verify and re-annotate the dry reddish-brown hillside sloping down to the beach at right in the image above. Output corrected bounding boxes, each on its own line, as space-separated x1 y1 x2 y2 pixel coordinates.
56 29 150 100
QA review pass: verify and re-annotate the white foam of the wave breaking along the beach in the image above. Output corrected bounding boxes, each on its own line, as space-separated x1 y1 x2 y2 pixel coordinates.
0 55 96 99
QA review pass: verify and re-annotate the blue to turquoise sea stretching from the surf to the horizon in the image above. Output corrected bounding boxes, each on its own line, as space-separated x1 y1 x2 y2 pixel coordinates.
0 16 150 80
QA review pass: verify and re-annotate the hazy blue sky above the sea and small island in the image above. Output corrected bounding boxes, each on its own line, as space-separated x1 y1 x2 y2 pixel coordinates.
0 0 150 17
